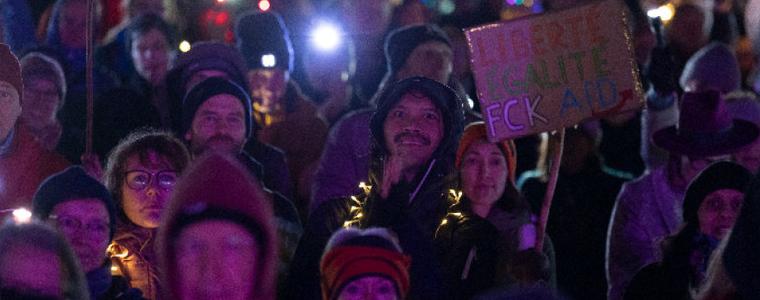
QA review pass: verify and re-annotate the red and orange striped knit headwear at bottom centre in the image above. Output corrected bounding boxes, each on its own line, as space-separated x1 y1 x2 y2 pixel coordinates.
320 231 411 300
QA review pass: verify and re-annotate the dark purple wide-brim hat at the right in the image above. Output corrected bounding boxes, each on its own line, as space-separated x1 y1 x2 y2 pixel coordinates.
652 91 760 157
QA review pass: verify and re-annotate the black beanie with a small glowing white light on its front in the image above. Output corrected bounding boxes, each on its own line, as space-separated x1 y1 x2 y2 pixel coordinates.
235 12 293 72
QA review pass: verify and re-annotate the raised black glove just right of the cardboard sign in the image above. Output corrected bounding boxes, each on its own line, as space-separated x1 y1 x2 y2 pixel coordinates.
646 47 678 94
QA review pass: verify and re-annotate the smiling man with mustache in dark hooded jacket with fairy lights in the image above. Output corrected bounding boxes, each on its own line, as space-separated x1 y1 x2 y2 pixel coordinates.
288 77 464 299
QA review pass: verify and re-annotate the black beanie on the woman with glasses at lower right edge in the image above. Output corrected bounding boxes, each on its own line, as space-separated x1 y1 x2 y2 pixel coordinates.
683 161 752 224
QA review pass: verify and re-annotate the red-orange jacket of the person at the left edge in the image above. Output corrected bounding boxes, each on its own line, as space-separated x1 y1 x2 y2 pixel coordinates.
0 123 69 210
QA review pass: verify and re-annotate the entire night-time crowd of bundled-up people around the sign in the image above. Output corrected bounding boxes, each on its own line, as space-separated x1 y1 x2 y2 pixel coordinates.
0 0 760 300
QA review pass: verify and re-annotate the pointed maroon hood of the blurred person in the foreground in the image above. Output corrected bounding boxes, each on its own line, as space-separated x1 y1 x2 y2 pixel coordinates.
157 154 277 299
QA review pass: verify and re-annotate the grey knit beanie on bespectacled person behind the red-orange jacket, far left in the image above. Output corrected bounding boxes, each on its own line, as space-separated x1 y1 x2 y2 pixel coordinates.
21 52 66 108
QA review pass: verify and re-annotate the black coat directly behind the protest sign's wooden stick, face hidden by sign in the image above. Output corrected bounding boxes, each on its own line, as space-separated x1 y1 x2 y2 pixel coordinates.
522 158 624 300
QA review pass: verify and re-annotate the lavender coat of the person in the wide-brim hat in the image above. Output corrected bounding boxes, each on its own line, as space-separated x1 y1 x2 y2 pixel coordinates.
607 166 684 300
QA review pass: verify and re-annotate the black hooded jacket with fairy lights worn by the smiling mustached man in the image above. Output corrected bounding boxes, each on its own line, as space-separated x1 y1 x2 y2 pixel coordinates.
286 77 464 299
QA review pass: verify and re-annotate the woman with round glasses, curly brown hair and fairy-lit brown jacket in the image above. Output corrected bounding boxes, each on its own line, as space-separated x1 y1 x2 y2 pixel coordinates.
103 130 190 299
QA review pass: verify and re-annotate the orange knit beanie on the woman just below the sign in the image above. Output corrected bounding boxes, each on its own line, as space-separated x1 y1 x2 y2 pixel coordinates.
454 121 517 184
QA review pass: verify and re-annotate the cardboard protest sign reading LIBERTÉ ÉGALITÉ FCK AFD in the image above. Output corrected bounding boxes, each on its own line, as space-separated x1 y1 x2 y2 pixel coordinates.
465 0 644 141
